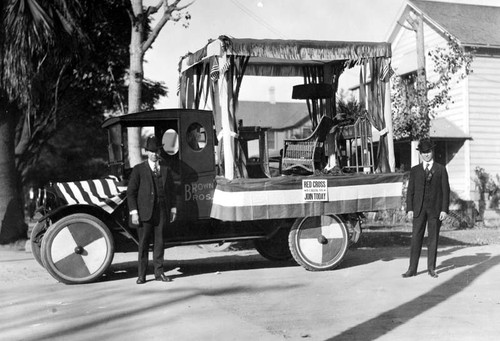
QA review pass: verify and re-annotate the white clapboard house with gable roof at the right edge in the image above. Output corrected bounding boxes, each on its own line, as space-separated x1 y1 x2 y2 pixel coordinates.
388 0 500 200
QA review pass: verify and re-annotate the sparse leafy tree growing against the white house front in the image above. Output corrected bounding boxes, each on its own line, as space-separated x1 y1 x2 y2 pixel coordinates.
391 35 472 140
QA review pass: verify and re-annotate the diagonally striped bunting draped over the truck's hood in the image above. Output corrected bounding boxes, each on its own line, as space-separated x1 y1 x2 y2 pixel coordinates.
55 176 127 213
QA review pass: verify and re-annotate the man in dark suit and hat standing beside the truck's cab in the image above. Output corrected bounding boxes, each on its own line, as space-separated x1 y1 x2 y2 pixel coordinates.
127 136 176 284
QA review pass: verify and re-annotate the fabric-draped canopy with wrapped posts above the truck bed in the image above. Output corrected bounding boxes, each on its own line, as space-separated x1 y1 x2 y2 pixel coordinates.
179 36 394 180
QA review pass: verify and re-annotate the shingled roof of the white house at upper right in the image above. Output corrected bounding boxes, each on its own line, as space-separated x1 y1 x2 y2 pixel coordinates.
409 0 500 47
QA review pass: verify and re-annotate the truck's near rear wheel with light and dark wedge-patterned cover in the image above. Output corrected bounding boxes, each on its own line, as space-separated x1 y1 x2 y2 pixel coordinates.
288 215 349 271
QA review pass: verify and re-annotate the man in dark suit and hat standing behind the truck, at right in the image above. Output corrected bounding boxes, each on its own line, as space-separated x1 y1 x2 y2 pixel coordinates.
402 139 450 278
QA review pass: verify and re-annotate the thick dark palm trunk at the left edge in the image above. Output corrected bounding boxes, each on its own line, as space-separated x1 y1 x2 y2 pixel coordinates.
0 98 27 244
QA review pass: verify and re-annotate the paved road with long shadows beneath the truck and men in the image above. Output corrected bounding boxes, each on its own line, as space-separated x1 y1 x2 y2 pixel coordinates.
0 245 500 341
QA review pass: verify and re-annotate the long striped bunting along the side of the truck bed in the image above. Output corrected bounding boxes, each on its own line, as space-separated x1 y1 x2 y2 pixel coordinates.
210 173 403 221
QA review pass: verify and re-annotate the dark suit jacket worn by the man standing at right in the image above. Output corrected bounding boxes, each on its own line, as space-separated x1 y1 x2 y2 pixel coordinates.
406 161 450 218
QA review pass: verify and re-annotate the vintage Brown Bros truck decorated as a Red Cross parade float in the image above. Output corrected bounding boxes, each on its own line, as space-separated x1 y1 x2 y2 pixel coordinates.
31 37 403 283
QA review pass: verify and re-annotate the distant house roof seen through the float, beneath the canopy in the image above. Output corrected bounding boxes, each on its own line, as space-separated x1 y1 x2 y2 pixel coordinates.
237 101 309 130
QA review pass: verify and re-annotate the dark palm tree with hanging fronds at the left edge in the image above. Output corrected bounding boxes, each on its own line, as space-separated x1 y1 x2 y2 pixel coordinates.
0 0 81 244
